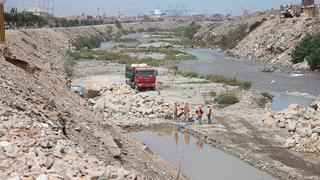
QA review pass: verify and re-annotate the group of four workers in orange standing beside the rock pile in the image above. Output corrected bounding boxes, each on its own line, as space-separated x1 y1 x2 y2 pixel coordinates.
173 103 213 124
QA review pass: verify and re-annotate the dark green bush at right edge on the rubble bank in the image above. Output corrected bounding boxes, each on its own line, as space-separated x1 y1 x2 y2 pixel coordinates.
291 32 320 70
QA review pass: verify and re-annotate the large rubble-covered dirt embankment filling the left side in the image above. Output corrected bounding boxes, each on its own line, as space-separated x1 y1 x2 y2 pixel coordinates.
0 23 185 179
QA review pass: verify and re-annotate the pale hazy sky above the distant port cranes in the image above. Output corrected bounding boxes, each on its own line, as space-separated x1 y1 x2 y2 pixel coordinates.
6 0 301 15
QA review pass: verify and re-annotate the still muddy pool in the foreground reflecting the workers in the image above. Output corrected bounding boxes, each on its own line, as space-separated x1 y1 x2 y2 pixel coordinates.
133 131 276 180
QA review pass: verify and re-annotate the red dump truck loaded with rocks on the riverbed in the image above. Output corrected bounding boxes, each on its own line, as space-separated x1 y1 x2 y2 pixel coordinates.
125 64 158 90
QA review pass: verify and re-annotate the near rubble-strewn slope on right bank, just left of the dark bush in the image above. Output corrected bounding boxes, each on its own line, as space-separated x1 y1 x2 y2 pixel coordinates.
231 17 319 68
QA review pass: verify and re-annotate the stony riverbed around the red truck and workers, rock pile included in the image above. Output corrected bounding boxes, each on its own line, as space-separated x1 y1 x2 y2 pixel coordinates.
73 61 320 179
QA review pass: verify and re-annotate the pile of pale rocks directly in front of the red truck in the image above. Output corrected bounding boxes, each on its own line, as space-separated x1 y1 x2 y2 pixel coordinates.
90 84 173 119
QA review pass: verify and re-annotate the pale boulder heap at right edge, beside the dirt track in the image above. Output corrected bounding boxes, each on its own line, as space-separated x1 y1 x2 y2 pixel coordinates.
263 101 320 152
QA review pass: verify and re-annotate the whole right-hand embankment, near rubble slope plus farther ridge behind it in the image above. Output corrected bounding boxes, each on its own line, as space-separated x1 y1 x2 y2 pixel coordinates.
197 11 319 69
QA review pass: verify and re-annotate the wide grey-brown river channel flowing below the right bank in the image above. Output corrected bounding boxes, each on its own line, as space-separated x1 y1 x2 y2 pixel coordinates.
179 49 320 111
